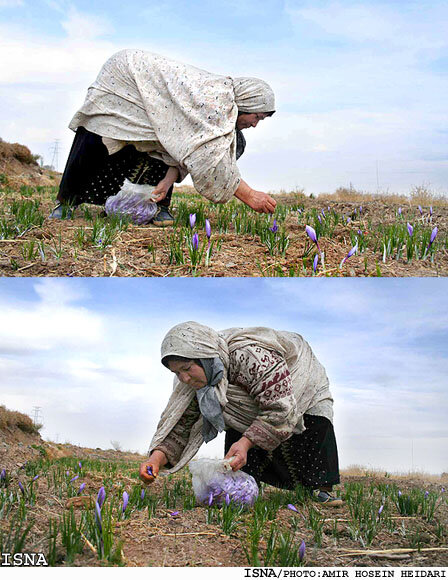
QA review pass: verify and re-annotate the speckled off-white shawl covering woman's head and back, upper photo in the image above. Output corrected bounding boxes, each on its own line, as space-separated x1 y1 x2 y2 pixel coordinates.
69 50 275 202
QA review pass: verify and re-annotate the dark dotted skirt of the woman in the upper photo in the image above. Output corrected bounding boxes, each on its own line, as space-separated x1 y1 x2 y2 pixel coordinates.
58 127 173 207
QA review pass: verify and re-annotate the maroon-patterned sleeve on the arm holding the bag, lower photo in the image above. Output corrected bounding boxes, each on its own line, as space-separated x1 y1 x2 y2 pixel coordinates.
229 345 299 451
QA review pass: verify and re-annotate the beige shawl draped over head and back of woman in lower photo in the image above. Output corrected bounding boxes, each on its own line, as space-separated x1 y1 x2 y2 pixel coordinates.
149 321 333 473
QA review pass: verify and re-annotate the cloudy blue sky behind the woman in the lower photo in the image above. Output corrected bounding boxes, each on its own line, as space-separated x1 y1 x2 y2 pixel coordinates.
0 278 448 474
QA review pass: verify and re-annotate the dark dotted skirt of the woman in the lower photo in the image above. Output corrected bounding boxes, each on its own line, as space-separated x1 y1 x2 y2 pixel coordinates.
225 415 340 489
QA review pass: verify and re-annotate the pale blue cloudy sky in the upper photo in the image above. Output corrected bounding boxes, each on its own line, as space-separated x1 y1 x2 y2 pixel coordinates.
0 0 448 195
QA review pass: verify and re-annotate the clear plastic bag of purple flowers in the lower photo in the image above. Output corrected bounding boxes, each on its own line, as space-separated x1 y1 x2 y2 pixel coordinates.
189 459 258 506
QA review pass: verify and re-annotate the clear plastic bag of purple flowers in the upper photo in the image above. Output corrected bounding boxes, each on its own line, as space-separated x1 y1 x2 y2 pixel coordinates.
105 179 157 225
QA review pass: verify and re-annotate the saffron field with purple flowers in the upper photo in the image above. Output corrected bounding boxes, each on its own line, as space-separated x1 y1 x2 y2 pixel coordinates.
0 184 448 277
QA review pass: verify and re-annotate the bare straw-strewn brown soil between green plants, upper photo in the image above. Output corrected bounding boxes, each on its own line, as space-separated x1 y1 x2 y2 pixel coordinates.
0 190 448 277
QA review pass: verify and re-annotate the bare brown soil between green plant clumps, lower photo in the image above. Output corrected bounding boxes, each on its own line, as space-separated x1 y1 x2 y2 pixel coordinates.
0 429 448 567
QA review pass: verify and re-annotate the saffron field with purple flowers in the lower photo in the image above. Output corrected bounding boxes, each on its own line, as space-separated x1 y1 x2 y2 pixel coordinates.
0 438 448 567
